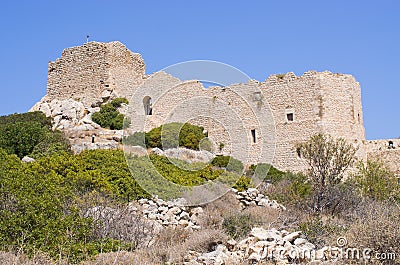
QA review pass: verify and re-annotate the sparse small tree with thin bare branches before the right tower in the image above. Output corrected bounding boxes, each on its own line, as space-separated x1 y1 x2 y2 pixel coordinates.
296 133 356 212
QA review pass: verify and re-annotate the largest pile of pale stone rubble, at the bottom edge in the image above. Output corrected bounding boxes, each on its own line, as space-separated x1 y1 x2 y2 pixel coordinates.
185 227 329 265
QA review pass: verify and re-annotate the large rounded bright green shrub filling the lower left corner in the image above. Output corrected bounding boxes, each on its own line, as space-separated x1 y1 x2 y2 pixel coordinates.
0 148 90 259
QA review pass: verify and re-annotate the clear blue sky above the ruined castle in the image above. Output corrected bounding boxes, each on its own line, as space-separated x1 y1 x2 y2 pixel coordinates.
0 0 400 139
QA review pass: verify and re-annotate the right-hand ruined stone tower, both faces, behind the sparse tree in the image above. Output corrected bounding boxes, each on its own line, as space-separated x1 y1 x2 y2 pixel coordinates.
260 71 365 171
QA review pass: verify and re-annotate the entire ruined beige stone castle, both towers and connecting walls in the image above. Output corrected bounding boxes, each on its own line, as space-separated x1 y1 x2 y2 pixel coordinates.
39 42 400 171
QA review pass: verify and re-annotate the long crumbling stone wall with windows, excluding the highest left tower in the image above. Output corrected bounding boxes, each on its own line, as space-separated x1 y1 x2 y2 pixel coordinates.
127 69 365 171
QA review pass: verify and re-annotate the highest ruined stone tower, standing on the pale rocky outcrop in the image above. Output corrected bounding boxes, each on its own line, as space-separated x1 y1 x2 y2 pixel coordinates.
47 42 145 106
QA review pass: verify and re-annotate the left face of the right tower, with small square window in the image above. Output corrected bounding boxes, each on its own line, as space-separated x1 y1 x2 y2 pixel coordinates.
260 72 321 171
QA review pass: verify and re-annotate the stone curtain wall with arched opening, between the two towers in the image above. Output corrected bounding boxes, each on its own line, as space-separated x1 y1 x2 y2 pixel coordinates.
129 72 275 164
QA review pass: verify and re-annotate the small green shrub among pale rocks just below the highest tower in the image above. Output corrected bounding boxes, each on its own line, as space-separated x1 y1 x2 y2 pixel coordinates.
92 98 128 130
